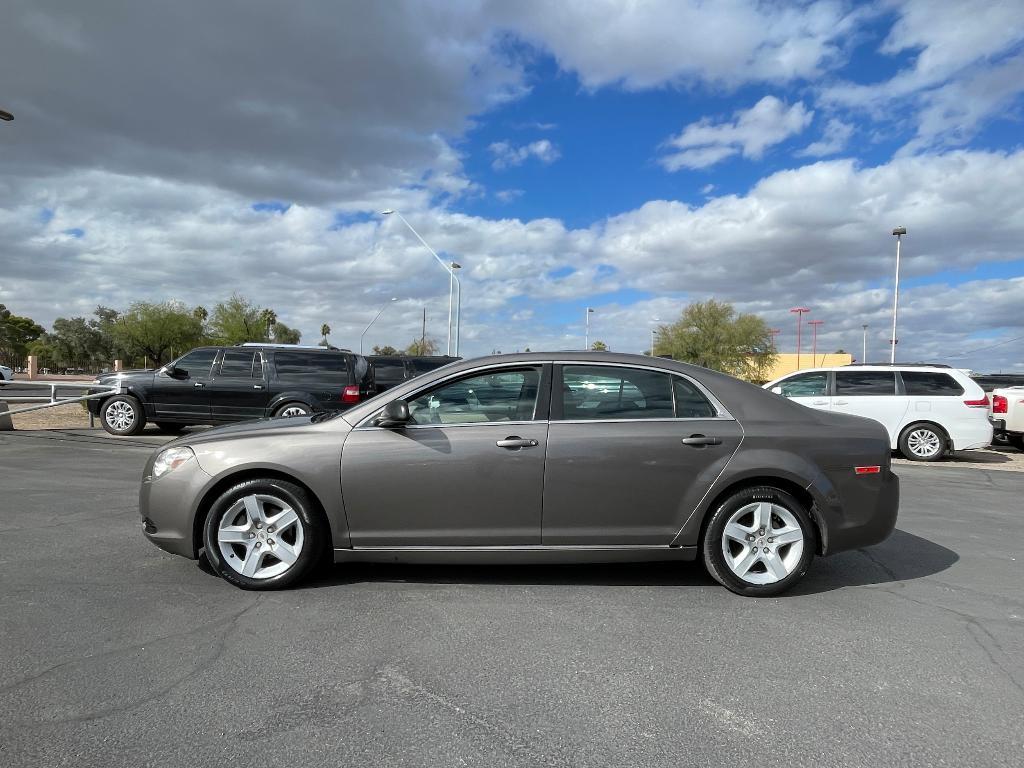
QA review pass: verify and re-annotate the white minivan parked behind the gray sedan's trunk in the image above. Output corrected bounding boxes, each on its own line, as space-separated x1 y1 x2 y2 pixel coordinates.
765 364 992 462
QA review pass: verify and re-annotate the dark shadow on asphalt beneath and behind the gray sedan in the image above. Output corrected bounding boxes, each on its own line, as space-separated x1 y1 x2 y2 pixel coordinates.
290 530 959 597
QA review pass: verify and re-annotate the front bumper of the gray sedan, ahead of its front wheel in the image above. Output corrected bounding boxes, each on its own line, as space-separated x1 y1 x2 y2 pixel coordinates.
138 459 213 559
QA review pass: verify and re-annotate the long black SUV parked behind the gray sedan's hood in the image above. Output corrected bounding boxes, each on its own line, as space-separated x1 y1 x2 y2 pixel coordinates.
88 343 375 435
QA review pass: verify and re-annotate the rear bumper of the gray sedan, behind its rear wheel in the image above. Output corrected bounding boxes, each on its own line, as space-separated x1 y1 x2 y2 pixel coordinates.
808 468 899 555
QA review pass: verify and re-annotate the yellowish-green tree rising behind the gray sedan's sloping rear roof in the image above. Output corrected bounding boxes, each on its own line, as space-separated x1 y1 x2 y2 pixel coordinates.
653 299 775 381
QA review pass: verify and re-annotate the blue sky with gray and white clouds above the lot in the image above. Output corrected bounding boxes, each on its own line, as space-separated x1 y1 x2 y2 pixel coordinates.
0 0 1024 370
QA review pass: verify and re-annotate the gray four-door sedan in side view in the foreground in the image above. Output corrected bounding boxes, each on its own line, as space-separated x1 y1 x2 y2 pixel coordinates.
139 352 899 596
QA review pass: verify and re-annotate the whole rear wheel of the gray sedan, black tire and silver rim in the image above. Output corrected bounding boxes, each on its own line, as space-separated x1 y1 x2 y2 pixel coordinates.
701 485 817 597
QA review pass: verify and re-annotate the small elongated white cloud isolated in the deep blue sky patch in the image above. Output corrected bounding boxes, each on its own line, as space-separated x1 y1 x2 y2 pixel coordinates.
658 96 814 171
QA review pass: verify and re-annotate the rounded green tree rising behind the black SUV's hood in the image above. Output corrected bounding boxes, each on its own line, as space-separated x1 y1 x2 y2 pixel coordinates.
105 301 203 367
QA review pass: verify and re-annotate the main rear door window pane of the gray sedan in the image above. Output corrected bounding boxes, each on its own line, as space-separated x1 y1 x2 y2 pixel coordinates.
562 366 675 420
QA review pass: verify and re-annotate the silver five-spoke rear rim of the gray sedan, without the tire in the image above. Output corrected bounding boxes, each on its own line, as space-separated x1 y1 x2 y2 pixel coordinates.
722 502 804 585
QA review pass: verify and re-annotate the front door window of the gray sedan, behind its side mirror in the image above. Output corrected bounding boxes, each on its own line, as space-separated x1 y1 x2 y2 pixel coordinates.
409 368 541 424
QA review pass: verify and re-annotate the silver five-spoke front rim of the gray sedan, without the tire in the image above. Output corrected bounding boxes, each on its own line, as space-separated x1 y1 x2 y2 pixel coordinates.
217 494 304 579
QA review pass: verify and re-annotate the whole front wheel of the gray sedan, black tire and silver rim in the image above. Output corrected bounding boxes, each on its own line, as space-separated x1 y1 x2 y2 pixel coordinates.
203 478 328 590
